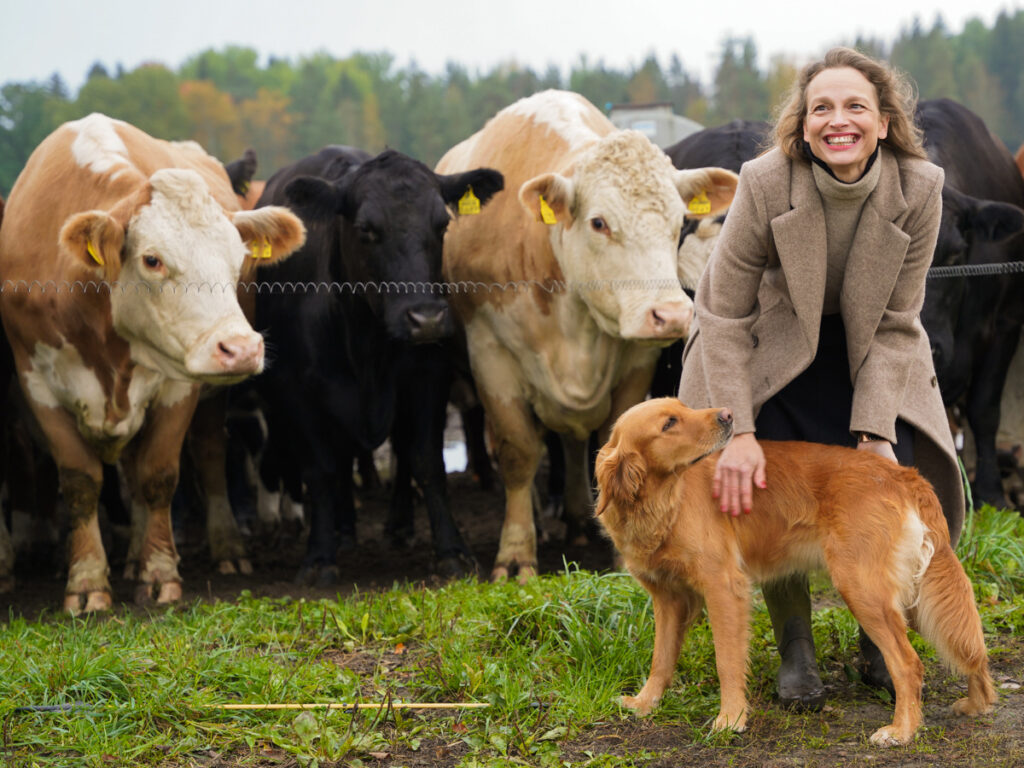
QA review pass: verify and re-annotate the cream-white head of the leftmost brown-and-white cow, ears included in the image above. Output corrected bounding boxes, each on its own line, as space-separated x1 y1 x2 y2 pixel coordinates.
61 169 304 383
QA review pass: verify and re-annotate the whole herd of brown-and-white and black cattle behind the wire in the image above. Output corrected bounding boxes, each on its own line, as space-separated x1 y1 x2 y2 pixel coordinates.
0 91 1024 612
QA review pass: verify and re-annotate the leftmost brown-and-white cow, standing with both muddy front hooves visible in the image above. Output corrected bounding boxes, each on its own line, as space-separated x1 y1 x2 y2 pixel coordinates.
0 114 305 612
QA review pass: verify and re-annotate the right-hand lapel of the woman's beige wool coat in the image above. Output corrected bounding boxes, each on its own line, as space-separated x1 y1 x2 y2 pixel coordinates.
840 150 910 372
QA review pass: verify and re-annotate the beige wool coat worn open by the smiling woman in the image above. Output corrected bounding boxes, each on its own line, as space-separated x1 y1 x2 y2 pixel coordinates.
679 145 965 544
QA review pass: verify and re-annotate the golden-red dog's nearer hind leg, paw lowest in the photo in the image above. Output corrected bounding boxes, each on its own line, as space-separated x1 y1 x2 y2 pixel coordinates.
833 585 925 746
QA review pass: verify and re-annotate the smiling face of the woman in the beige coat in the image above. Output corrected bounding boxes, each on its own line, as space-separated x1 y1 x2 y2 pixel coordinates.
804 67 889 181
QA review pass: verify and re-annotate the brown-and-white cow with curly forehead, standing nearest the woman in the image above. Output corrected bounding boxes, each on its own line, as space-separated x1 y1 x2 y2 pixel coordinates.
437 91 737 581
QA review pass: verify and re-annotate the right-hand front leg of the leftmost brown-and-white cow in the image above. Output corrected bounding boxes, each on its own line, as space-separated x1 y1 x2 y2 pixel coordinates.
125 393 199 604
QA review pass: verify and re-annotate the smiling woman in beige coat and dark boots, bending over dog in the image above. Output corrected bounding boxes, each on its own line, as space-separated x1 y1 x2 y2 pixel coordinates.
679 48 965 708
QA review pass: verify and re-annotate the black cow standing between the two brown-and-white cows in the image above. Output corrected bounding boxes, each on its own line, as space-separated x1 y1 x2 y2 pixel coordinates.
256 146 504 584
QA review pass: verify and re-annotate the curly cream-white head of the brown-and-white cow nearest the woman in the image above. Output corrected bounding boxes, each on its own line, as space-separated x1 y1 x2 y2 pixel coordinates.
519 131 736 343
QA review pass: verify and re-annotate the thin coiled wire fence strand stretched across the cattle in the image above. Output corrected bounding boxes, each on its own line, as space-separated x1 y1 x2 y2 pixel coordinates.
0 261 1024 296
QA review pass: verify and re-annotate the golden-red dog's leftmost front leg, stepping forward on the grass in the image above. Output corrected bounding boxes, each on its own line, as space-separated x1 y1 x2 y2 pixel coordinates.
621 581 701 715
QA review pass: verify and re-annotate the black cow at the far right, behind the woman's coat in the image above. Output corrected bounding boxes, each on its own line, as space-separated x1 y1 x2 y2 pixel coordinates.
916 98 1024 506
